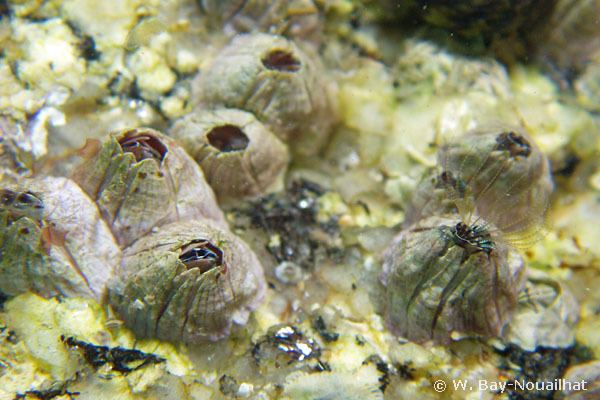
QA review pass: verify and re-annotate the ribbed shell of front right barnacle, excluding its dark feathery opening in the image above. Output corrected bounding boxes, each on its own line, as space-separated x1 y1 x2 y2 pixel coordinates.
381 216 524 342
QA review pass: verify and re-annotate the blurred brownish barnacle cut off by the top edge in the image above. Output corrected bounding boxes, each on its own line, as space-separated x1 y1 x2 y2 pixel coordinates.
198 0 322 39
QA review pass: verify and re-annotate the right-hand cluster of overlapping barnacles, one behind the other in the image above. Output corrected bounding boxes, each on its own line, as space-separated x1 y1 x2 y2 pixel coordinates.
381 128 554 343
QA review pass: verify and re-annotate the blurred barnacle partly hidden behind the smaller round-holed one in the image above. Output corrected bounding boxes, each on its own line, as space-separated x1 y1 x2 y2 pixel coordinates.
193 33 333 154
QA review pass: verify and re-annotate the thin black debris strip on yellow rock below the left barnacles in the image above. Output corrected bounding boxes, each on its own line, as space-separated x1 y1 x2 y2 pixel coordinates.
61 336 165 374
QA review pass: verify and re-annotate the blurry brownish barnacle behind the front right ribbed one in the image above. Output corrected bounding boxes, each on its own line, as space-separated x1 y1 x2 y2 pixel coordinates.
438 128 554 233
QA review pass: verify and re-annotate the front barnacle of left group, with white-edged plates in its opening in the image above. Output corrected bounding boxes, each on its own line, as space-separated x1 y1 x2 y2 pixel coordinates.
108 220 265 343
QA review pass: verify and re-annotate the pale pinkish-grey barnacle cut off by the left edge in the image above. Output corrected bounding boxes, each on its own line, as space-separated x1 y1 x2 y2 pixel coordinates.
0 177 121 300
